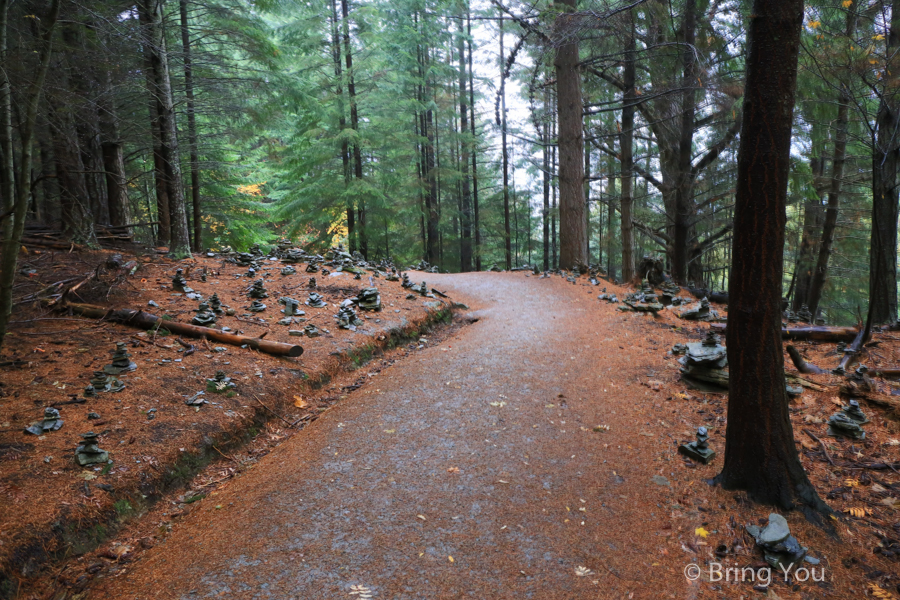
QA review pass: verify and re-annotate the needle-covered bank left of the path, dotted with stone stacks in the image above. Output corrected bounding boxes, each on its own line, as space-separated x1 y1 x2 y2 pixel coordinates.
0 246 460 597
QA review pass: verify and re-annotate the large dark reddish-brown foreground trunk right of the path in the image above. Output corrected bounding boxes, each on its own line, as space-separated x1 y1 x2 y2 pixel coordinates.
718 0 828 514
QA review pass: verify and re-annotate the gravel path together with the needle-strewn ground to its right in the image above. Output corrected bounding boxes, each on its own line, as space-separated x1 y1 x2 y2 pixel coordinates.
7 264 900 599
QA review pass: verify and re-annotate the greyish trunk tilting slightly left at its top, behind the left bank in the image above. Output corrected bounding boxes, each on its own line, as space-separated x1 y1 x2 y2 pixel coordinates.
137 0 191 258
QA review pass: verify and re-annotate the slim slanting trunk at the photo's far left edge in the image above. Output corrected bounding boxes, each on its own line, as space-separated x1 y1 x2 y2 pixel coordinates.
0 0 61 348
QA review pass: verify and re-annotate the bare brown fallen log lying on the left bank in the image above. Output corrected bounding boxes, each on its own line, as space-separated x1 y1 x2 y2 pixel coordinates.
60 302 303 357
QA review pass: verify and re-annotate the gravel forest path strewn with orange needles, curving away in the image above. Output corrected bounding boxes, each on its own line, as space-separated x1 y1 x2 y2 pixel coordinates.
88 273 692 600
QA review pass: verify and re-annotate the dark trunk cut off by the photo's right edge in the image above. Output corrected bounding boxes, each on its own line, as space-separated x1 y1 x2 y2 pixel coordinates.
867 0 900 324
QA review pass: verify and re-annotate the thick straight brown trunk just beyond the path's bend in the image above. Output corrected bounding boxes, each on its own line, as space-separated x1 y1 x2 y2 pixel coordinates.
554 0 587 269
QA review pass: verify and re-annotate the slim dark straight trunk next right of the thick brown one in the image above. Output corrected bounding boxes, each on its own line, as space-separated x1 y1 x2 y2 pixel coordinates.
619 14 636 283
